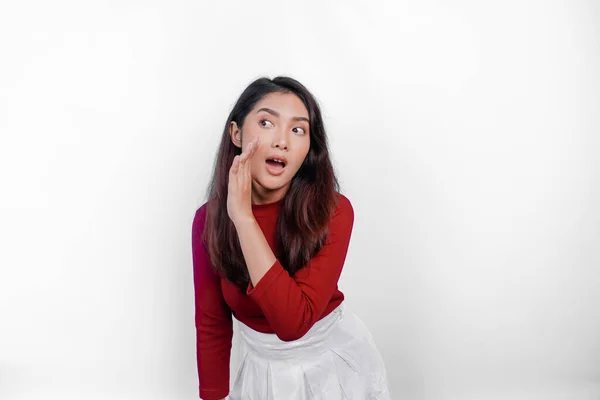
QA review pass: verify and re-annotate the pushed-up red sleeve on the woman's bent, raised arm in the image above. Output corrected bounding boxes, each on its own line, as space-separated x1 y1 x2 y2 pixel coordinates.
246 196 354 341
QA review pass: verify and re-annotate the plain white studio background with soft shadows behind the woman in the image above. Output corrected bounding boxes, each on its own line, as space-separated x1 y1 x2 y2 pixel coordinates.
0 0 600 400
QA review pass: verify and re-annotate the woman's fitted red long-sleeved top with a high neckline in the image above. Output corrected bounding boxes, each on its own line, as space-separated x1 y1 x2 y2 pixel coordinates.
192 195 354 400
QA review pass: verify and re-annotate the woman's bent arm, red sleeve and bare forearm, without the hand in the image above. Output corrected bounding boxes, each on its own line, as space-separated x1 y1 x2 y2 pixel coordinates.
236 195 354 341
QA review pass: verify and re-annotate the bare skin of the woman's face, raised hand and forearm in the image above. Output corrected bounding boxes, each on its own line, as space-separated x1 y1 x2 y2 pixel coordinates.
227 93 310 304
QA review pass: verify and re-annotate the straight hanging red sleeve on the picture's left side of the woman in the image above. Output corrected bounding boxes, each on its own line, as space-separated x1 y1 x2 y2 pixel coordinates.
192 205 233 400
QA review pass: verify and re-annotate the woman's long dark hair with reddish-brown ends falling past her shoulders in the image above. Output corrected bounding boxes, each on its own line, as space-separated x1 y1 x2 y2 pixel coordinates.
203 76 339 291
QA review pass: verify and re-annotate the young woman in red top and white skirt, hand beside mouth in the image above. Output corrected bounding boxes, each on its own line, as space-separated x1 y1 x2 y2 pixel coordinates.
192 77 390 400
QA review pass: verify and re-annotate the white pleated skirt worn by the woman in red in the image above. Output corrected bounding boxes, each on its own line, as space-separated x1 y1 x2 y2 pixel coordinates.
227 303 391 400
